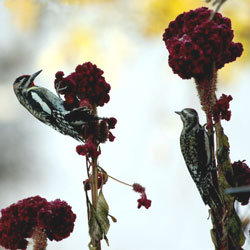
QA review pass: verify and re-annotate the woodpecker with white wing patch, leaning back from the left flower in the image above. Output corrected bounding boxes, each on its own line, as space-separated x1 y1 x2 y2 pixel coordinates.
13 70 99 141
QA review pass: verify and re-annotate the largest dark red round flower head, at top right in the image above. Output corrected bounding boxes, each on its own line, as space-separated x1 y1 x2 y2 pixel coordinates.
163 7 243 79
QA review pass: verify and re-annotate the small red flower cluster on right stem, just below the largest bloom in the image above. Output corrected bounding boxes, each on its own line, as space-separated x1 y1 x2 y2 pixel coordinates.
213 94 233 122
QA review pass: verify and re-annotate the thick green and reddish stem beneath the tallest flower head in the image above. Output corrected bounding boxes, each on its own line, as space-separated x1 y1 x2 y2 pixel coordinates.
195 69 244 250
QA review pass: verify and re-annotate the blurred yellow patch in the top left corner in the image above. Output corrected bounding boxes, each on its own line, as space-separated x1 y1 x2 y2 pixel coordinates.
4 0 42 31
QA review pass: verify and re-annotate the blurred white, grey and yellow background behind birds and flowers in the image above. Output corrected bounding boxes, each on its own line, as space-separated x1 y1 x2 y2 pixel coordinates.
0 0 250 250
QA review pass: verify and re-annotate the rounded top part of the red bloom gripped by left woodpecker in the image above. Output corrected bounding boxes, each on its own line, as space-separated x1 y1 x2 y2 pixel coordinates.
55 62 110 108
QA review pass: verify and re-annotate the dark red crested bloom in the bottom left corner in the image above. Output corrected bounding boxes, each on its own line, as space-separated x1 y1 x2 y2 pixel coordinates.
0 196 76 250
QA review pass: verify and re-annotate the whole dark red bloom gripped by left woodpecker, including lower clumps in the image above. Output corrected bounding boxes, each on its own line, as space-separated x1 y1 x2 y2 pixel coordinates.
54 62 117 157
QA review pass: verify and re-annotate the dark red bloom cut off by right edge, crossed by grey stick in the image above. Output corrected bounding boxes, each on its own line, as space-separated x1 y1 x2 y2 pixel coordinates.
229 161 250 205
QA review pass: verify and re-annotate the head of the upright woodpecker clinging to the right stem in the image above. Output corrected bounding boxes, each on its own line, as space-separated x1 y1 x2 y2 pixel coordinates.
175 108 199 129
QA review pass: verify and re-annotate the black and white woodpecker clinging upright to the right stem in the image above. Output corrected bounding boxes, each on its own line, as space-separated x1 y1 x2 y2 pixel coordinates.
175 108 222 208
